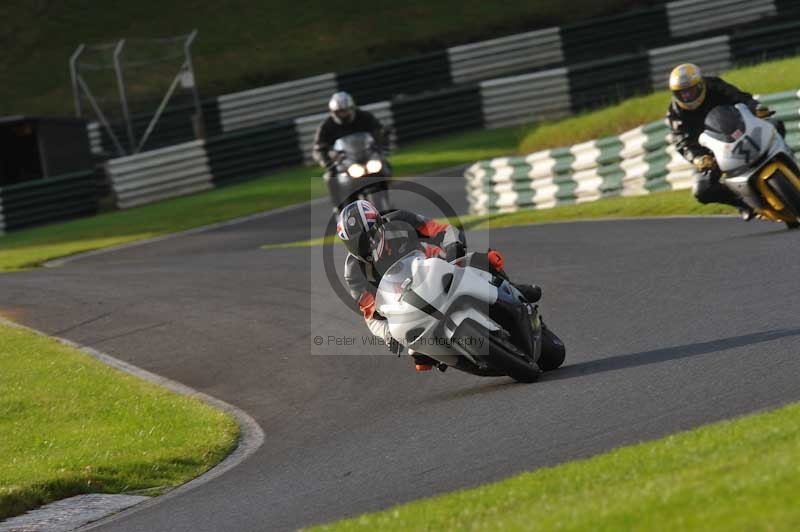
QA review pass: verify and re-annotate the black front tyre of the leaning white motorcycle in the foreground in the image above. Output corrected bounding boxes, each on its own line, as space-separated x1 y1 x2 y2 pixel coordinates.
454 319 541 382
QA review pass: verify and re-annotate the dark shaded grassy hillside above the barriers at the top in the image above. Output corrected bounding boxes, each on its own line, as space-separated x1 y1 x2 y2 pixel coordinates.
0 0 663 116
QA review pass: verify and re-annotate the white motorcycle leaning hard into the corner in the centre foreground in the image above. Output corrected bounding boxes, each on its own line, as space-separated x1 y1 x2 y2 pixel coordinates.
375 222 566 382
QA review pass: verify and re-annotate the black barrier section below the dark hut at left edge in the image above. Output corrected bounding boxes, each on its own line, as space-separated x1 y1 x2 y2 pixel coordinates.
0 171 97 232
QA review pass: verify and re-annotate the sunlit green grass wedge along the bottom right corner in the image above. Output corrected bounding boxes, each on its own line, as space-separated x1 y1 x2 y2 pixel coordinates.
312 404 800 532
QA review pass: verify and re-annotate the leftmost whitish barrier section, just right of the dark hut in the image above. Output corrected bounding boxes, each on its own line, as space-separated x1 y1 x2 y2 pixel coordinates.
106 141 213 209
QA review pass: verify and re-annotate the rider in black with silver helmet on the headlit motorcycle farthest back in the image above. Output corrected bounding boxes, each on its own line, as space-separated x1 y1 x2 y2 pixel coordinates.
312 91 386 210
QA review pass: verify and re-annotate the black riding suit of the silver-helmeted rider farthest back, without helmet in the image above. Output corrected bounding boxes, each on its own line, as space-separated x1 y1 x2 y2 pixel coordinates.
312 109 386 207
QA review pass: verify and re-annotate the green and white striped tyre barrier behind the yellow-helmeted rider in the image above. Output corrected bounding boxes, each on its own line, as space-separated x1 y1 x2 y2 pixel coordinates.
465 91 800 214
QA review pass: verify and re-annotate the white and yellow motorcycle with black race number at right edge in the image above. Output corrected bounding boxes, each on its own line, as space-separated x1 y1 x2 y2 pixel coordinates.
699 103 800 229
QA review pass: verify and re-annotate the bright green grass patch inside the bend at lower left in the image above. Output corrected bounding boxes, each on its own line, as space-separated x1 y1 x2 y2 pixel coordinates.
0 323 239 520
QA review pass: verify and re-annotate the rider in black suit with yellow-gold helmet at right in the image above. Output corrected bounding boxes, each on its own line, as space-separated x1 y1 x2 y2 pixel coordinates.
667 63 786 220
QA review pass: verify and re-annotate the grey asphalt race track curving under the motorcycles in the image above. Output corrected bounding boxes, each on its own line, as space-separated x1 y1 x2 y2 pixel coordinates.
0 172 800 532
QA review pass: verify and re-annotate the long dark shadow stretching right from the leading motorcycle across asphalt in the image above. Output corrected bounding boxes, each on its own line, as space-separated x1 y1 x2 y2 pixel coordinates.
542 329 800 381
